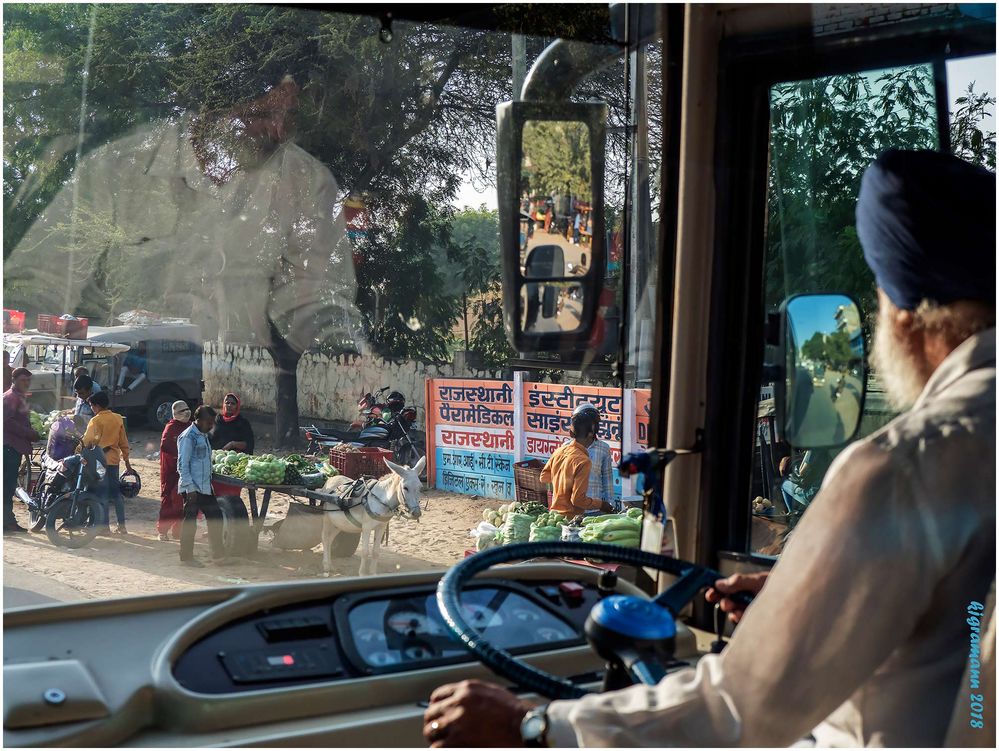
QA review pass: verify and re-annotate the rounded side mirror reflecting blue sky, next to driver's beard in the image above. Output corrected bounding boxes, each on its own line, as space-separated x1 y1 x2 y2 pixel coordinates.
774 294 867 448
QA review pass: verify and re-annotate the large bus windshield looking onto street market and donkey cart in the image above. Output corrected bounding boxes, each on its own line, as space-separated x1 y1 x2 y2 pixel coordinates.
3 4 662 599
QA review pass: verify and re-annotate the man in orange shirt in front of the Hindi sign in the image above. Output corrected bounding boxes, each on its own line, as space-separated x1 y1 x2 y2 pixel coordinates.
541 410 614 519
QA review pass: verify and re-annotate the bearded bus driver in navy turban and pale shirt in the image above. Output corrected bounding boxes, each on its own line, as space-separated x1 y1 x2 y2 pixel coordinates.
424 151 996 747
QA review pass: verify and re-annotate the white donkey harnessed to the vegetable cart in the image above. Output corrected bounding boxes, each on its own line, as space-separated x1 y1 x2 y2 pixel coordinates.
323 456 427 576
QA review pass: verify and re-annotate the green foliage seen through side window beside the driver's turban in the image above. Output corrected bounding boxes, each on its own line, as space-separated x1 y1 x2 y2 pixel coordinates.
766 65 995 326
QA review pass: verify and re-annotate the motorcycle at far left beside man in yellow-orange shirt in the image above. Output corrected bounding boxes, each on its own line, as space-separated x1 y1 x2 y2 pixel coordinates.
16 446 107 548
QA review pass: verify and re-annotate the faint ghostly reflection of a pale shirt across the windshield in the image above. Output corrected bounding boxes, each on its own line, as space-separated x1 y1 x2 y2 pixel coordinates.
4 118 358 350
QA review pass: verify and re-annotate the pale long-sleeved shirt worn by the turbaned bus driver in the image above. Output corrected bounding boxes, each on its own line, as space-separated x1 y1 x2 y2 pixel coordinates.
549 329 996 747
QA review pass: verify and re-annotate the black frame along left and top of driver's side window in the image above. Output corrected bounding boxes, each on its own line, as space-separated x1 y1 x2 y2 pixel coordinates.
692 20 996 628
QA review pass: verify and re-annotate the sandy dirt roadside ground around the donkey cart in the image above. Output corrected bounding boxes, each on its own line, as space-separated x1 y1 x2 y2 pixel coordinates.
3 429 502 599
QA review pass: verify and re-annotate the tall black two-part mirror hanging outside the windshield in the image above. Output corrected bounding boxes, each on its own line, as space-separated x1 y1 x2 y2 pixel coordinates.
496 102 607 352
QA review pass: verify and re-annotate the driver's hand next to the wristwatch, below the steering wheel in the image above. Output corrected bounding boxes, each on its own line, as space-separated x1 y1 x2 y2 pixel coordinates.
423 681 534 748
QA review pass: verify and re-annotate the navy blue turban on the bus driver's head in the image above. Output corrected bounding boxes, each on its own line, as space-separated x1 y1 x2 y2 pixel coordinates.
857 151 996 310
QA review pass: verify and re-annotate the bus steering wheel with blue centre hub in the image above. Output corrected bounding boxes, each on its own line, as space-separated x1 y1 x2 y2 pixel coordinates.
437 542 752 699
